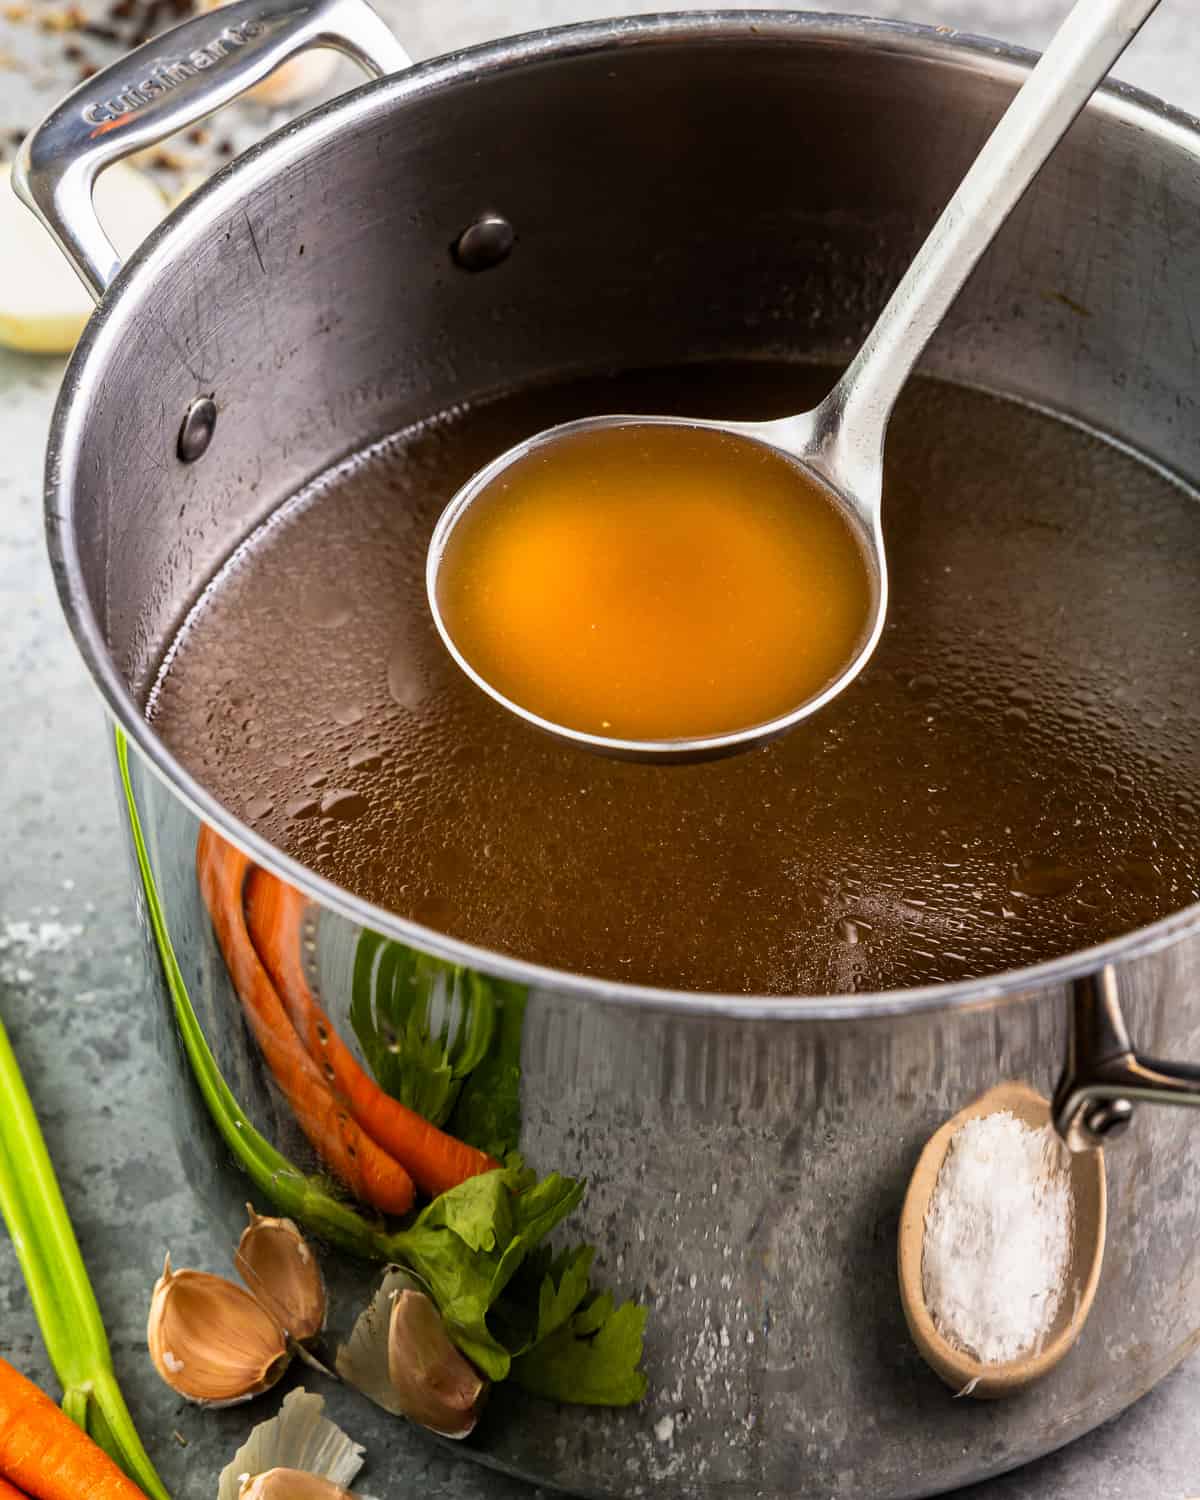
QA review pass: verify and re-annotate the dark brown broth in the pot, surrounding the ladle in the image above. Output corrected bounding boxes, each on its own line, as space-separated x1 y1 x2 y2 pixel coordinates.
149 363 1200 993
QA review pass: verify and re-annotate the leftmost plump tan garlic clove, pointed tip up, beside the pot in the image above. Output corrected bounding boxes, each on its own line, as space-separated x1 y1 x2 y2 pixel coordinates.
146 1256 290 1406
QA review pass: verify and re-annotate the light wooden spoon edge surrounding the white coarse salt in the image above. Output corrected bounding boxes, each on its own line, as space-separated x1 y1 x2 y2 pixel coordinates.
897 1083 1107 1400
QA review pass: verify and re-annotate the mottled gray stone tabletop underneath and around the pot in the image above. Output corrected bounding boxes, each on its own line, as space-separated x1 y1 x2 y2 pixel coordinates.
0 0 1200 1500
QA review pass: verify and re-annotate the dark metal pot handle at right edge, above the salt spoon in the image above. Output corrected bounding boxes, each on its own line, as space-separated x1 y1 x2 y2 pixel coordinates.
1052 965 1200 1151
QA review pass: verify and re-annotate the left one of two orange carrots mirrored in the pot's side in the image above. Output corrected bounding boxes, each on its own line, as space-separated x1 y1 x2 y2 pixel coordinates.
197 827 414 1214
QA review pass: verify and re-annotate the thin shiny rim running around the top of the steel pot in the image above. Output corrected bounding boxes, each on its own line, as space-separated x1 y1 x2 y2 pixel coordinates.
45 11 1200 1022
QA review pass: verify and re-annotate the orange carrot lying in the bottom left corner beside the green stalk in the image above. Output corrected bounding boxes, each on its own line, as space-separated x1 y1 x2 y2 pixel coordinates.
0 1359 146 1500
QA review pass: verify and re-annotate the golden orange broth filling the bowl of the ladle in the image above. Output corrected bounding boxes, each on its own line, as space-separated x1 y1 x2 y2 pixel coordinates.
438 422 875 741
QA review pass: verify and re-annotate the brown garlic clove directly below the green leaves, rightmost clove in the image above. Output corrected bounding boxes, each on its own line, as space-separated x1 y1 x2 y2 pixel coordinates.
387 1292 488 1437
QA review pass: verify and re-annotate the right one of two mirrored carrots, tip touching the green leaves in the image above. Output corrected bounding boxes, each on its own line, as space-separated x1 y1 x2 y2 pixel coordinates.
246 869 500 1197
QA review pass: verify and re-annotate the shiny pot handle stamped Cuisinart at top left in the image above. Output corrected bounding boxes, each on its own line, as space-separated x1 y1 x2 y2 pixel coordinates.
12 0 410 302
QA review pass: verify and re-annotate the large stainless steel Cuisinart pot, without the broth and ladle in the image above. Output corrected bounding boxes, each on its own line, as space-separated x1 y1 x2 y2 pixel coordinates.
23 0 1200 1500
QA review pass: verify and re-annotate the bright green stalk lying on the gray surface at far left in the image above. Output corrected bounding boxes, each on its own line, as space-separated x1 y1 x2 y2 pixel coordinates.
0 1022 170 1500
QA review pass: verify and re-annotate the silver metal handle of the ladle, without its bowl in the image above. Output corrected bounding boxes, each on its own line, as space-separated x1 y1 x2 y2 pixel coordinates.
815 0 1158 506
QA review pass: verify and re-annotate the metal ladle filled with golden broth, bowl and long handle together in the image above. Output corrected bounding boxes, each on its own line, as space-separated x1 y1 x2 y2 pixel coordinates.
426 0 1158 761
